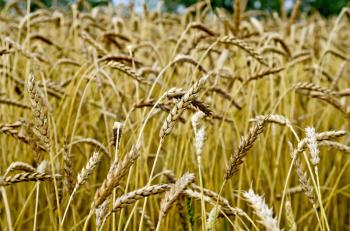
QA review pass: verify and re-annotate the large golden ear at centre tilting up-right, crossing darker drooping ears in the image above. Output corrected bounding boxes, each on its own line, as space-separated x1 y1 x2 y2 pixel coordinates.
159 73 212 139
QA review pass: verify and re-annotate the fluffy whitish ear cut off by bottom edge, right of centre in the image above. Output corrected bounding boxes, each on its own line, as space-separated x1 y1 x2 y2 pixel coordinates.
243 189 280 231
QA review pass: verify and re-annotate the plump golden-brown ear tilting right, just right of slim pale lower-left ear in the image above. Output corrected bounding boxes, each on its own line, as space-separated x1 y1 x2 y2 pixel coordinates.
93 144 140 208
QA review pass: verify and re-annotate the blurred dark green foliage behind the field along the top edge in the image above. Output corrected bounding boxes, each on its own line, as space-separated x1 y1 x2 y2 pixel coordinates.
0 0 350 17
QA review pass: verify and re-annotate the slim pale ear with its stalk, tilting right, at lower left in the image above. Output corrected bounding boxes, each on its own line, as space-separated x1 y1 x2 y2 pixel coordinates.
61 152 101 224
